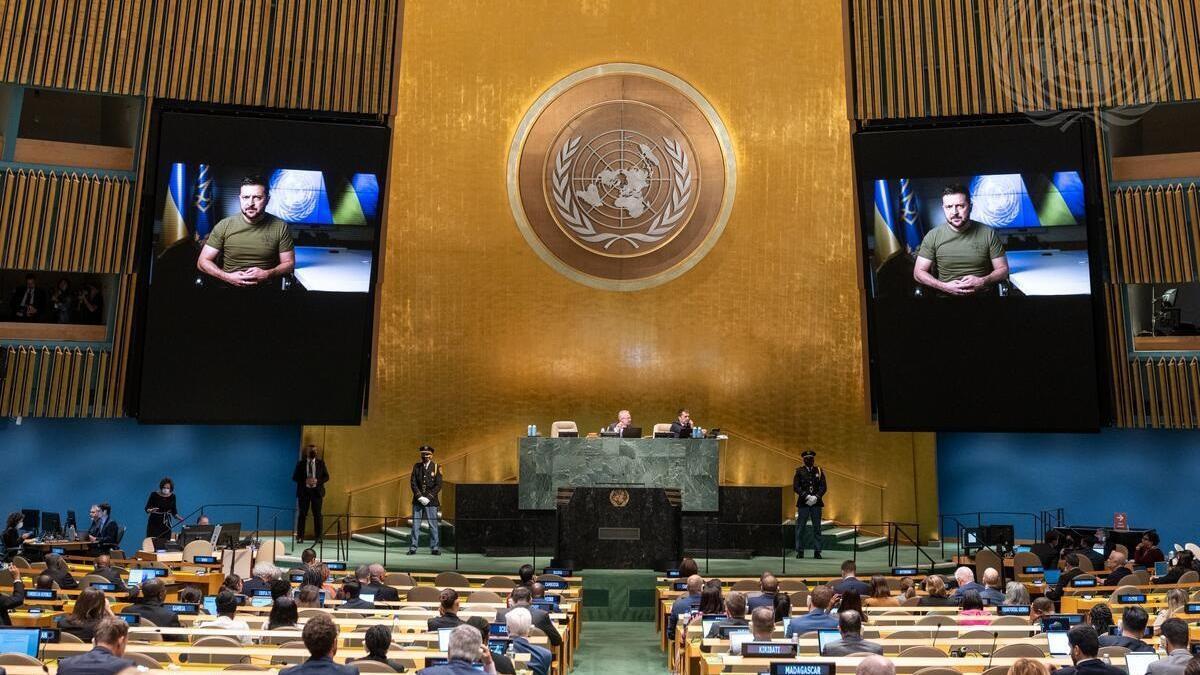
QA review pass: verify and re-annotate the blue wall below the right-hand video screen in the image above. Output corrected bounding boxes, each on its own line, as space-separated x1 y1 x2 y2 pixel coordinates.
937 430 1200 549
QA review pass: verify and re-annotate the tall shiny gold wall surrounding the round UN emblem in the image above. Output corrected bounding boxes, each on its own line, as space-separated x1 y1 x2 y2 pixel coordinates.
306 0 937 534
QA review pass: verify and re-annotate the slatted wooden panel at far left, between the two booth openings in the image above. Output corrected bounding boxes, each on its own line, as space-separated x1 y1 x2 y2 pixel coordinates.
0 169 134 274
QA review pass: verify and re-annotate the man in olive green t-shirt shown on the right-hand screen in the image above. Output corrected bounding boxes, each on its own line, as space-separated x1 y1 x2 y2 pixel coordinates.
912 185 1008 295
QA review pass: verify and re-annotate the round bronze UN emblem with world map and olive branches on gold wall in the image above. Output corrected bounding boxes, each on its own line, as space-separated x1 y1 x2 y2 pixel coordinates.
508 64 737 291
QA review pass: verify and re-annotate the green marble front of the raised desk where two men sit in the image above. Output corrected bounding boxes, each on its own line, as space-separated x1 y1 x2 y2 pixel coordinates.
517 436 720 510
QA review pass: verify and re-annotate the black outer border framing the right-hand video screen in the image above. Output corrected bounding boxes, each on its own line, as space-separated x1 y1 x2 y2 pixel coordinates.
852 114 1111 432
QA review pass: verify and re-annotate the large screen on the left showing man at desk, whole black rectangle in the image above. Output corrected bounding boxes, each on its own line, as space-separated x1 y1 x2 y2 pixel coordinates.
131 109 389 424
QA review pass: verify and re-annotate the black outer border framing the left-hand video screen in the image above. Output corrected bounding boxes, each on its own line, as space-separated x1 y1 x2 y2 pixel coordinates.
125 100 391 425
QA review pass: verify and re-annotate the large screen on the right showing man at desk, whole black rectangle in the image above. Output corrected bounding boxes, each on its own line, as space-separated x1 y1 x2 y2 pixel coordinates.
854 124 1100 431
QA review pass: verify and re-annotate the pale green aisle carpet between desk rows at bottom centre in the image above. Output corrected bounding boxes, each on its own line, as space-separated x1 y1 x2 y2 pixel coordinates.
571 621 668 675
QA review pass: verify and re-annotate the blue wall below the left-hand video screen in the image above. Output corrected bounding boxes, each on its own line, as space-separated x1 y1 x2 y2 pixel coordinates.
0 418 300 540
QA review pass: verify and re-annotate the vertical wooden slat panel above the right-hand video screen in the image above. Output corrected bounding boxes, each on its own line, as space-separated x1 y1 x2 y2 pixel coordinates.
846 0 1200 120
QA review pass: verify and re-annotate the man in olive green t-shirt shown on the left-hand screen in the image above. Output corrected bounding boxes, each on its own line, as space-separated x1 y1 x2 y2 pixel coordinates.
196 175 296 286
